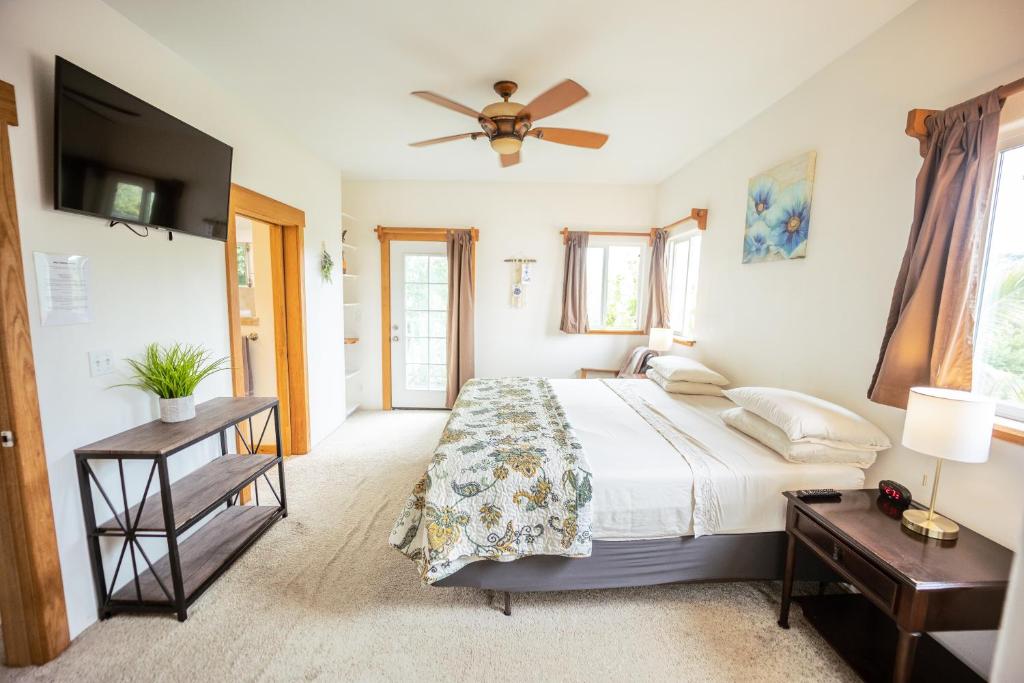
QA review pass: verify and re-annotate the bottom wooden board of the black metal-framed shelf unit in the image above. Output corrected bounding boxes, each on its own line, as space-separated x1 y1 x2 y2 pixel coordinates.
113 505 282 604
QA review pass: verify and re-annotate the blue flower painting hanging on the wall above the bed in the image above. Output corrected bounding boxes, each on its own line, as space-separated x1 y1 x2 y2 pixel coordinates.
743 152 817 263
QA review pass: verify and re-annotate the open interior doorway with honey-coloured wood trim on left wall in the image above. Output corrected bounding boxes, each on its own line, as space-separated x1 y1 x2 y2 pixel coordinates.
224 184 309 456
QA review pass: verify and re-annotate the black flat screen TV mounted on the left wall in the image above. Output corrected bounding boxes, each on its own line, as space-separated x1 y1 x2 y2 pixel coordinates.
53 57 231 241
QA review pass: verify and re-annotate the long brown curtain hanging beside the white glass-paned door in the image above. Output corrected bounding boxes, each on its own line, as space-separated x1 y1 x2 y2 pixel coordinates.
444 230 476 408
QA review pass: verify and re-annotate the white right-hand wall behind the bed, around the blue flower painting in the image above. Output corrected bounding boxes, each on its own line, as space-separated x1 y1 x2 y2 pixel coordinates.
656 0 1024 669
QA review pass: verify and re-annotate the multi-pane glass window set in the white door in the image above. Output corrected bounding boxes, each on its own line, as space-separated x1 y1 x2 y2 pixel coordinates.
404 254 447 391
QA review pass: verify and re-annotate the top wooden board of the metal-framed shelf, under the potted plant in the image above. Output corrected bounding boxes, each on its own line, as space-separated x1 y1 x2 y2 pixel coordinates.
75 396 278 460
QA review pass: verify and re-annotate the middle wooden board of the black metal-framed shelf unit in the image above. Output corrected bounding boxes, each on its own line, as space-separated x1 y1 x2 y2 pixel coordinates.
99 454 278 531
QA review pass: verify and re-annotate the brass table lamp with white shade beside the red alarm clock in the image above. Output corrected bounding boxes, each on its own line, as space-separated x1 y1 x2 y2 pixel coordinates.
903 387 995 541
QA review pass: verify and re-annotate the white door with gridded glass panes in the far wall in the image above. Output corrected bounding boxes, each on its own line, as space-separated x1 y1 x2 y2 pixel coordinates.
391 242 447 408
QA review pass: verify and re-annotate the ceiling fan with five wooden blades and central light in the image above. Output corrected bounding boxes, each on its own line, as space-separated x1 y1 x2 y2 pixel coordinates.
410 79 608 167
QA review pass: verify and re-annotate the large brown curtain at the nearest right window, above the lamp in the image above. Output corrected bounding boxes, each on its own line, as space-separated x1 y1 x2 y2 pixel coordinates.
867 91 1002 408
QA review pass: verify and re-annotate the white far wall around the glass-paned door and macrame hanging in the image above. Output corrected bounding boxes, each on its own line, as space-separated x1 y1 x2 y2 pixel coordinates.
343 181 654 408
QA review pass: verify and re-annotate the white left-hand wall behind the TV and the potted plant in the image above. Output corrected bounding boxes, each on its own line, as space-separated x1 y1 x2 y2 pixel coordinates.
0 0 344 636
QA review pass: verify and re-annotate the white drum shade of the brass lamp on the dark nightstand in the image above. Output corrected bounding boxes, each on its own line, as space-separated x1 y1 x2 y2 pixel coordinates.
903 387 995 463
